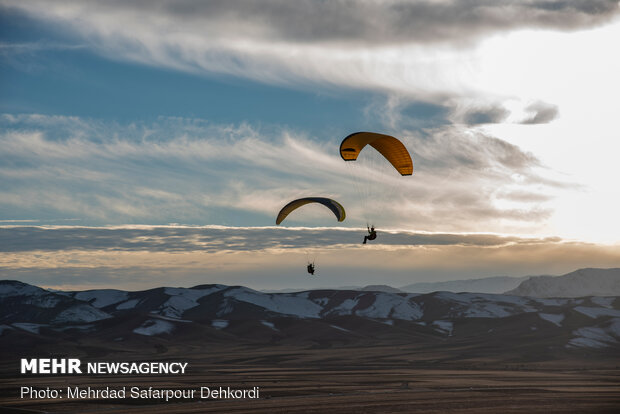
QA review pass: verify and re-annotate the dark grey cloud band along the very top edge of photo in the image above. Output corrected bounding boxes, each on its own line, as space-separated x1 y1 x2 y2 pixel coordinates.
2 0 618 46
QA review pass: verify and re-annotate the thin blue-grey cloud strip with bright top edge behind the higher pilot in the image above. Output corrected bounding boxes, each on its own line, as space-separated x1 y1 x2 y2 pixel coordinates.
0 226 561 253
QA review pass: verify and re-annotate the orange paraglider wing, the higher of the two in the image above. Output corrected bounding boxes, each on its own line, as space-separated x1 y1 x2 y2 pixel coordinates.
340 132 413 175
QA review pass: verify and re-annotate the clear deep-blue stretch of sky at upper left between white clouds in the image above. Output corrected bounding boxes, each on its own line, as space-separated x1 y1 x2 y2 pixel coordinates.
0 10 386 134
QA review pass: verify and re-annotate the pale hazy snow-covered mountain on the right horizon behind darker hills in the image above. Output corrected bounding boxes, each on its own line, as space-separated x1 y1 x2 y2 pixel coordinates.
506 268 620 298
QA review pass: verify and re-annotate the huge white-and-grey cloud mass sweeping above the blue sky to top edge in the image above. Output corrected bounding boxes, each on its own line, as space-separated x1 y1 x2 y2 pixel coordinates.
1 0 620 124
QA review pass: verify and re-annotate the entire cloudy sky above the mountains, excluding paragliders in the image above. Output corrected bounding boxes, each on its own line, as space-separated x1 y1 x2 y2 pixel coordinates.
0 0 620 289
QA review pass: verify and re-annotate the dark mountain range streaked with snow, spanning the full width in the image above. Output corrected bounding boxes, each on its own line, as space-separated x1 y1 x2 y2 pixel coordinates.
0 281 620 355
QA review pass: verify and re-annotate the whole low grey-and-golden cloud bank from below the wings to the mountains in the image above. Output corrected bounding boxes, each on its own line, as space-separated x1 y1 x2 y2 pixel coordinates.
0 226 620 289
